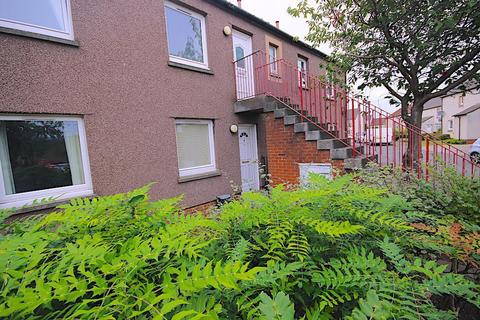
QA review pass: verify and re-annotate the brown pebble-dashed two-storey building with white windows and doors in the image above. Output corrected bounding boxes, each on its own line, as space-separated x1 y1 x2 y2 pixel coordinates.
0 0 351 212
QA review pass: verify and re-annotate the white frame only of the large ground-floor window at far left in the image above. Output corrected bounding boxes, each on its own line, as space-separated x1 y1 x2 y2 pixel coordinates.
0 115 93 209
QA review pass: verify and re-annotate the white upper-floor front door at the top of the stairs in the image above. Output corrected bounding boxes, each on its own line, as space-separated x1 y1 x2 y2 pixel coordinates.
232 30 255 99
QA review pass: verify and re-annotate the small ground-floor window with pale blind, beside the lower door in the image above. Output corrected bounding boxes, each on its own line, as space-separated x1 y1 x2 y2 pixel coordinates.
176 119 216 177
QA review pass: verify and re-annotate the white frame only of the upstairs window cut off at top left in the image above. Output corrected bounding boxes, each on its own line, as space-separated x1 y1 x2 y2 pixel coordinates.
0 0 74 40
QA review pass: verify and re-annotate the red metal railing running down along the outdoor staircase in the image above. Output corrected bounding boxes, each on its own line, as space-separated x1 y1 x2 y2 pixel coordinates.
234 51 480 179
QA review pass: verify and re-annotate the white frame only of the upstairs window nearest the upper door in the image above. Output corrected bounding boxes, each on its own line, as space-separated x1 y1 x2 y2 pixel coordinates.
165 1 208 69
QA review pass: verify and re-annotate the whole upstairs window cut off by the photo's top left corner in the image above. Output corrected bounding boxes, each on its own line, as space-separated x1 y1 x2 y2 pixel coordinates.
0 0 73 40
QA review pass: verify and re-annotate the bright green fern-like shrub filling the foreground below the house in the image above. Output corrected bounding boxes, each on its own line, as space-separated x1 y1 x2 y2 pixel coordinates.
0 176 480 320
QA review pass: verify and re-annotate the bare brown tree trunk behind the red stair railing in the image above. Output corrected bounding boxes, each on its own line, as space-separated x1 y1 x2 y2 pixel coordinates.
403 102 423 175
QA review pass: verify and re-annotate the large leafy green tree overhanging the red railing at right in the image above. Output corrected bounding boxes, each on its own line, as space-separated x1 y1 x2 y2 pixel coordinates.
289 0 480 164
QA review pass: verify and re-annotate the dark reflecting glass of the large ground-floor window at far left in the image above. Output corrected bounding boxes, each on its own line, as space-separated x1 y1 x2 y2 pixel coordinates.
0 120 85 194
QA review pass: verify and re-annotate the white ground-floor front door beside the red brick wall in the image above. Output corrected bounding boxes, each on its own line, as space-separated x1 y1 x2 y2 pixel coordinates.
238 124 260 192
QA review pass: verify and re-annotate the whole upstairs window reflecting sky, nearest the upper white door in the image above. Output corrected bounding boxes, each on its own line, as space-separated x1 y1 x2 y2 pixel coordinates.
165 2 208 69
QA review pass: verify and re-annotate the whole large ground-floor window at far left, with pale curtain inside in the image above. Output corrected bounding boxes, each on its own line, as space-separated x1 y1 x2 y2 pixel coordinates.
0 116 92 207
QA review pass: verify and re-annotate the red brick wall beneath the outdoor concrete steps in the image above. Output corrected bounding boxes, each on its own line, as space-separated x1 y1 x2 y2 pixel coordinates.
262 112 343 185
